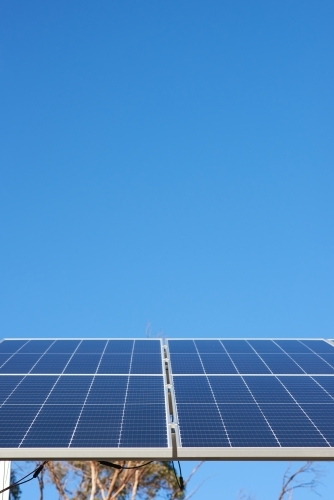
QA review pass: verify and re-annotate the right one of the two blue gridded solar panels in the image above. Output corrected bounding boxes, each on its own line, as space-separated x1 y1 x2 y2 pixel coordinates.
168 339 334 456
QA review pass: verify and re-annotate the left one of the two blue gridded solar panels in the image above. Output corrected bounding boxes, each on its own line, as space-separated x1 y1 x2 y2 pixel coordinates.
0 339 168 449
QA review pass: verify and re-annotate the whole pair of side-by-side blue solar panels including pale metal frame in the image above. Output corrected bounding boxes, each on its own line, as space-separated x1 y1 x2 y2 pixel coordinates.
0 339 334 460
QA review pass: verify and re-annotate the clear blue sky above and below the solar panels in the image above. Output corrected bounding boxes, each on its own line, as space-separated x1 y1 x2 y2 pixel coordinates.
0 0 334 500
